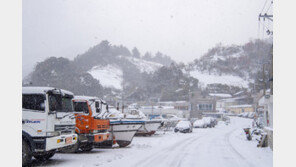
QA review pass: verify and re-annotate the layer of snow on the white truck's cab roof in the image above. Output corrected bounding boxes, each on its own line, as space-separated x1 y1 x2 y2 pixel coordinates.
22 86 74 96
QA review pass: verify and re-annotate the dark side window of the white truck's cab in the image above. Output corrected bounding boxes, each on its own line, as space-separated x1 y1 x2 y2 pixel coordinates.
22 94 45 111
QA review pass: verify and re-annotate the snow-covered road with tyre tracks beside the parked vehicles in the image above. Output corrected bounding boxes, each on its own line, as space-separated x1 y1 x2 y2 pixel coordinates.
33 117 273 167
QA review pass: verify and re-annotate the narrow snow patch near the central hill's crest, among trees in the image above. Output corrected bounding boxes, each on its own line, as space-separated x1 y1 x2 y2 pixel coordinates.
124 57 163 73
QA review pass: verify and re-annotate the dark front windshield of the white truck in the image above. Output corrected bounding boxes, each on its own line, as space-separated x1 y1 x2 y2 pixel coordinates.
49 94 73 112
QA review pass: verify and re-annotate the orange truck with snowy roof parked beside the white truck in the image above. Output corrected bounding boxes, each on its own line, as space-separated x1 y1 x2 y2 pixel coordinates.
64 96 110 152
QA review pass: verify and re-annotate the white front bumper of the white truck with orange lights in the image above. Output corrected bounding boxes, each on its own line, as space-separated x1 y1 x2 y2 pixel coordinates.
45 134 77 151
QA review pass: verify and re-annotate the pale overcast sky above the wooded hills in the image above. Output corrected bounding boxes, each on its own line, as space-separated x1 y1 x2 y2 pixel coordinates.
23 0 265 75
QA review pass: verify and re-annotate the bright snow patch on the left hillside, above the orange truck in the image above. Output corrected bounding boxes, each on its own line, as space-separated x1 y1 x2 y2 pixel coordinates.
88 64 122 90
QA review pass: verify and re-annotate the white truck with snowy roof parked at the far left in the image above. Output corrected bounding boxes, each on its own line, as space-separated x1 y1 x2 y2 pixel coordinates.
22 87 77 166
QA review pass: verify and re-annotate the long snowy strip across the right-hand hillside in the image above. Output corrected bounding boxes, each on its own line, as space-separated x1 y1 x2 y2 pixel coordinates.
190 70 249 88
